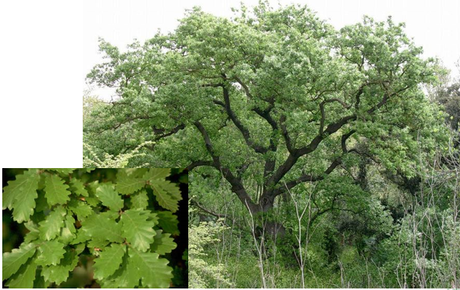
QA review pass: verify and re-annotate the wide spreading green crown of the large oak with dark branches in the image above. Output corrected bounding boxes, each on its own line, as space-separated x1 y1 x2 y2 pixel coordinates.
85 2 444 219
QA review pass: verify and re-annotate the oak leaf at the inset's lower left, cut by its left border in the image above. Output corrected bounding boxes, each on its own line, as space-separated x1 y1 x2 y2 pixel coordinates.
2 243 36 280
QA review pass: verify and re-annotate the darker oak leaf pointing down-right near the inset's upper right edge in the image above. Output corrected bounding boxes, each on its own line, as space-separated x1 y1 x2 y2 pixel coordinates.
150 180 182 212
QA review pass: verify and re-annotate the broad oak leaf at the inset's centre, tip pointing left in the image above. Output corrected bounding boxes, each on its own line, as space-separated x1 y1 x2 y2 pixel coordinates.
81 213 123 243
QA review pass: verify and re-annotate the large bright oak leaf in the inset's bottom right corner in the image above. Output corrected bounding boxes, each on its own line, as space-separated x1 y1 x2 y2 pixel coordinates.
128 249 173 288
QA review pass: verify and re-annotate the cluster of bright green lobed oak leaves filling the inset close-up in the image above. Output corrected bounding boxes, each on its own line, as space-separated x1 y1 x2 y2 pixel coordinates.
2 168 185 288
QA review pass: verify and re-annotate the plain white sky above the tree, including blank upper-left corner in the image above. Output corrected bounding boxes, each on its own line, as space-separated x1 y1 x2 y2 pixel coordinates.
0 0 460 168
